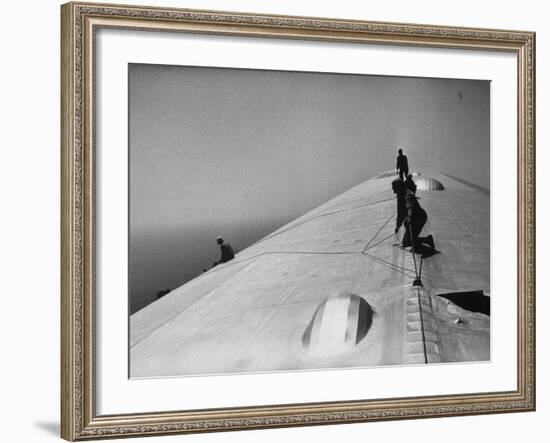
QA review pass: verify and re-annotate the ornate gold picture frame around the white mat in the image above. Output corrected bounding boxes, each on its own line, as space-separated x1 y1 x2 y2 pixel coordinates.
61 2 535 441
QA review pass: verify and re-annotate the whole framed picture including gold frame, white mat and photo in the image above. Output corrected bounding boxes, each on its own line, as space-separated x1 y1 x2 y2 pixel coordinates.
61 2 535 441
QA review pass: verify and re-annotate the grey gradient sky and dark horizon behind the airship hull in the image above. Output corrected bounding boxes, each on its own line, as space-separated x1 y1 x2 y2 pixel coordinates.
129 64 490 313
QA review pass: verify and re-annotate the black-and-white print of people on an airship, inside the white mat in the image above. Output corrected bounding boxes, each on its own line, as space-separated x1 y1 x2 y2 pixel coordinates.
128 63 492 378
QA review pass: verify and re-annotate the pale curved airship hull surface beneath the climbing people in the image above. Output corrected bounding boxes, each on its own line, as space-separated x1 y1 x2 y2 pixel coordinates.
130 174 490 377
